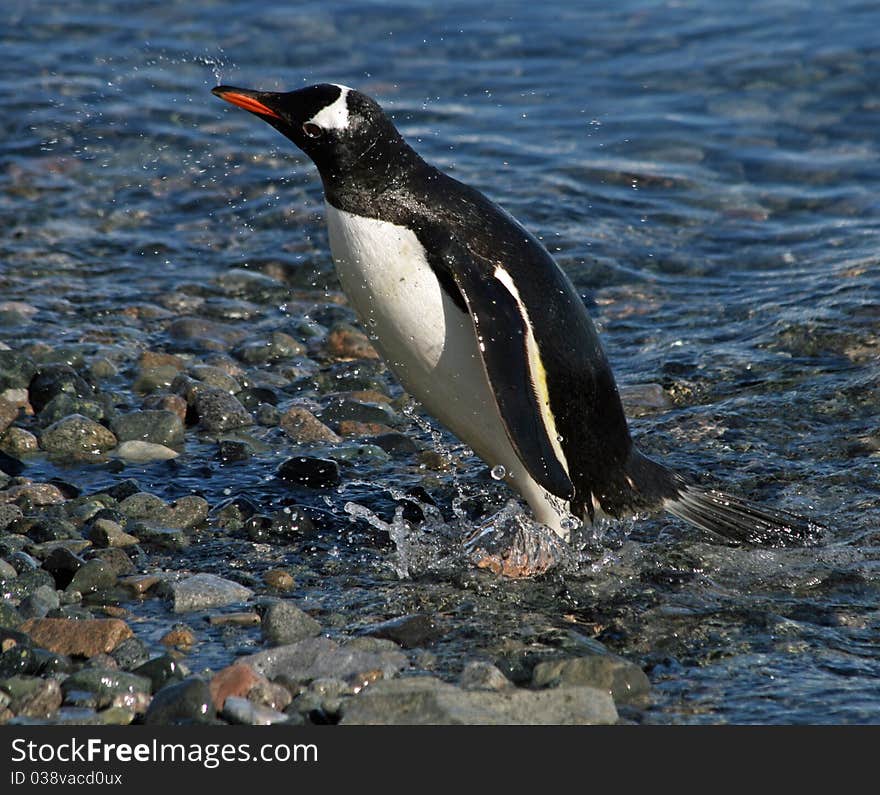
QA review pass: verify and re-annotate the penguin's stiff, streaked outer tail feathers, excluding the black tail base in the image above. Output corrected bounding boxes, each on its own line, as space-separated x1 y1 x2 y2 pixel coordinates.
663 483 826 547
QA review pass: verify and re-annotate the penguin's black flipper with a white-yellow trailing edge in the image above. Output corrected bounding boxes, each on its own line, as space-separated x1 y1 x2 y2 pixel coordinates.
445 248 574 500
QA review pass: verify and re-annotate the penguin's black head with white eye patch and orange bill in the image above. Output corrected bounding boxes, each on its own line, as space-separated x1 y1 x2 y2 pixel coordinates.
212 83 411 182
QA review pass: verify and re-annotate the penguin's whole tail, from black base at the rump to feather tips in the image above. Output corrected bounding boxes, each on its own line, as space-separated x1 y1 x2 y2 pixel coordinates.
626 450 828 546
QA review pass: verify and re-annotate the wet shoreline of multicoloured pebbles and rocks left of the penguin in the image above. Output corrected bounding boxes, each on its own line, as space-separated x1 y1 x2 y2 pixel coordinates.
0 270 667 725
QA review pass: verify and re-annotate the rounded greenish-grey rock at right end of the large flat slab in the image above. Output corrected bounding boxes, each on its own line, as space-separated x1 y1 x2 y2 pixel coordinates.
532 654 651 704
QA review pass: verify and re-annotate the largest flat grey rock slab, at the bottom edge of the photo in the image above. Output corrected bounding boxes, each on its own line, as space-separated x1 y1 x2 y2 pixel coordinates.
341 677 617 725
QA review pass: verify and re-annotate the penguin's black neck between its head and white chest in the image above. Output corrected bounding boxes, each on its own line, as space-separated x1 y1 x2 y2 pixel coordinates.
318 137 431 214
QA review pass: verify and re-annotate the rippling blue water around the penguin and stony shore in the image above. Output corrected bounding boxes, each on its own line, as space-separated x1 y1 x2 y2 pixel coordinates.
0 0 880 723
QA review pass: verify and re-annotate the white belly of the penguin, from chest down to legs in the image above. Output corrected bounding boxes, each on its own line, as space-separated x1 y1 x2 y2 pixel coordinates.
326 204 568 536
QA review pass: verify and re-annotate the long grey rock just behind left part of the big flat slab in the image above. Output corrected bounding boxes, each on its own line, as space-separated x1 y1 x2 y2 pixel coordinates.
242 636 407 681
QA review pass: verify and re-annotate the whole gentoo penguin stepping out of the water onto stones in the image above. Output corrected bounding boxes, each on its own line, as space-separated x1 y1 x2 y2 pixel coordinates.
213 84 815 543
